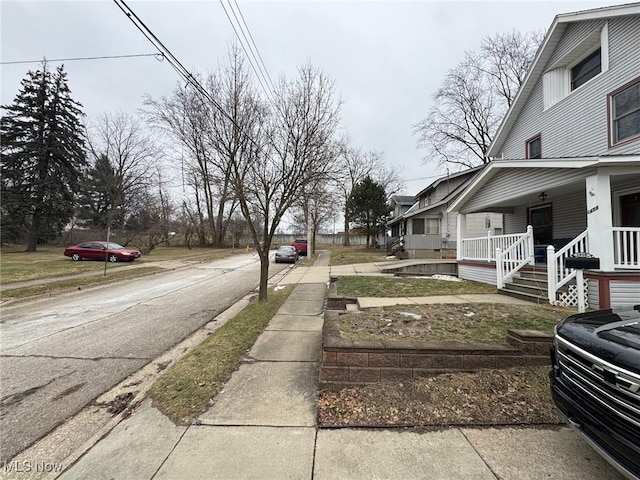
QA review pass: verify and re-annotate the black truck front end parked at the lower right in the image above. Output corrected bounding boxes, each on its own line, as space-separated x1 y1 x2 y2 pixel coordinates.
550 305 640 479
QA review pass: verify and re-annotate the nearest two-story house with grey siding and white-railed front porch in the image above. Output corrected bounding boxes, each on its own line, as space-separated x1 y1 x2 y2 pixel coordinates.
449 3 640 308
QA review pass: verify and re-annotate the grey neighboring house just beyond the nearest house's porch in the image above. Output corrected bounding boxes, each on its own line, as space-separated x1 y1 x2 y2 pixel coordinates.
387 167 502 258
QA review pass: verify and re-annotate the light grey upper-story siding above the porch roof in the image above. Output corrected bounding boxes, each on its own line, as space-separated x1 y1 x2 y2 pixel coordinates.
501 15 640 159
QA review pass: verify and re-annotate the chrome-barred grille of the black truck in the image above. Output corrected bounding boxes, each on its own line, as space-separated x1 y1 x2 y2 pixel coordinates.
556 336 640 437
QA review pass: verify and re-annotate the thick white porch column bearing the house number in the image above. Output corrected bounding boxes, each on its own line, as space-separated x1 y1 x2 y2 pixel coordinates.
586 172 613 272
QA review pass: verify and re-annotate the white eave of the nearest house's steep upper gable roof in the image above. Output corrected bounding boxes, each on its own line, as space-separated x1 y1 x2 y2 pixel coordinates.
487 3 640 158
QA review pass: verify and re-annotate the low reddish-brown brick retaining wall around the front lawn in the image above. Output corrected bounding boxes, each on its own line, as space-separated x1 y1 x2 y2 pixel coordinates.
320 310 553 385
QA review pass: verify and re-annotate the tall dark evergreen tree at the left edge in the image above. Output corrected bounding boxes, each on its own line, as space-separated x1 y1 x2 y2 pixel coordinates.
0 62 86 252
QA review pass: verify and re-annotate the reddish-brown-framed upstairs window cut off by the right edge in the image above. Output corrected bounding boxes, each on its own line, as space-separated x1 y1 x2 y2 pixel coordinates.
609 78 640 145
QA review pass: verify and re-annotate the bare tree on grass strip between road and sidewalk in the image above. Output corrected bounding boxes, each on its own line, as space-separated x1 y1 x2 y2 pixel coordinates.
232 65 340 301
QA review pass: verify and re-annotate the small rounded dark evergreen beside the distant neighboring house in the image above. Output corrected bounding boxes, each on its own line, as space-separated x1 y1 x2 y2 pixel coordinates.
347 176 391 247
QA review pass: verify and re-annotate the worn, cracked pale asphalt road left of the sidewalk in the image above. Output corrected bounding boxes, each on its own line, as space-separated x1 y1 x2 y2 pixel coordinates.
0 254 284 462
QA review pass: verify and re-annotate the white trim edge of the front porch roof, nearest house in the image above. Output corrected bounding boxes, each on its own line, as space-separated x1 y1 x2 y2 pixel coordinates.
447 155 640 212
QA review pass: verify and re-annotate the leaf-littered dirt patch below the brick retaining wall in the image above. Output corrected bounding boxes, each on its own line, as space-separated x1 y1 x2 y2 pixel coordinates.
318 366 561 427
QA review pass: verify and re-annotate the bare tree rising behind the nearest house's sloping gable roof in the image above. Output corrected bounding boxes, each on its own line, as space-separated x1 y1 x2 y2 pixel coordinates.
414 31 542 168
